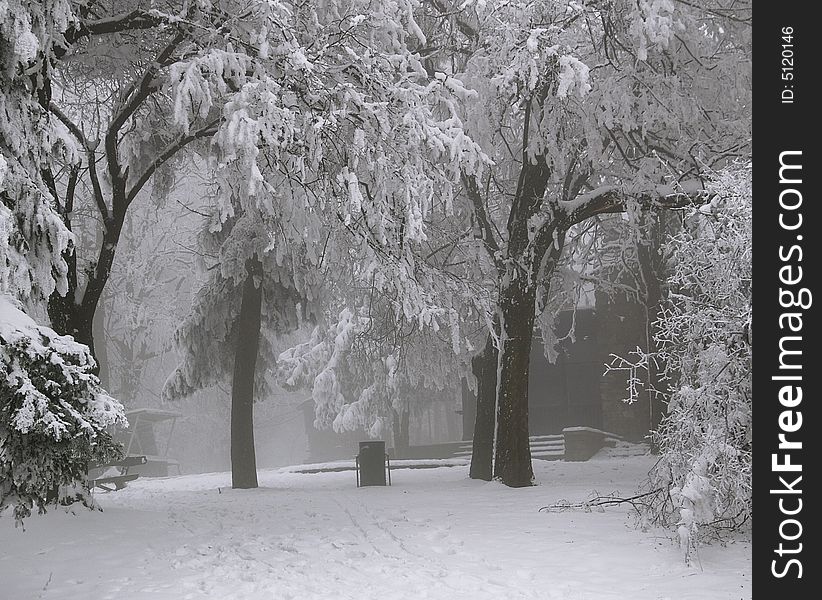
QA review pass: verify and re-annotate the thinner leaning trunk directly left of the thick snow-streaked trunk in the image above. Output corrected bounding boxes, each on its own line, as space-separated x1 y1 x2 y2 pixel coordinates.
469 335 499 481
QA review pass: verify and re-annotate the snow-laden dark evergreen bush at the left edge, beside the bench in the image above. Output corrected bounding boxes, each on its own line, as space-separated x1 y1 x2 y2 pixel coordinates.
0 295 125 522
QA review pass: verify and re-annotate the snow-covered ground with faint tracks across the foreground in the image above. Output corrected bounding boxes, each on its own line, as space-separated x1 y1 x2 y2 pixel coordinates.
0 456 751 600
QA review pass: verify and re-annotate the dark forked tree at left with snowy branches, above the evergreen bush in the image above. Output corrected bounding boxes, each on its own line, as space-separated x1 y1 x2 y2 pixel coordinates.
29 1 264 352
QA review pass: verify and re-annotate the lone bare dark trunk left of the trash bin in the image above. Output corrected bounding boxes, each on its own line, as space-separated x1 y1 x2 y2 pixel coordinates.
231 259 263 489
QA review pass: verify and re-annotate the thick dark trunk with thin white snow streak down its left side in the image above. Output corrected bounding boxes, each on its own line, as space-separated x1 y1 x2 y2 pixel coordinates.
494 276 536 487
